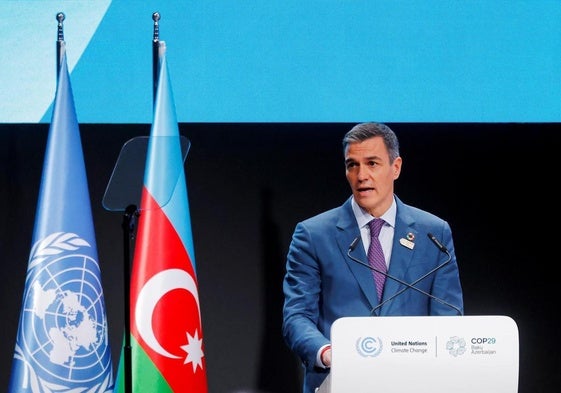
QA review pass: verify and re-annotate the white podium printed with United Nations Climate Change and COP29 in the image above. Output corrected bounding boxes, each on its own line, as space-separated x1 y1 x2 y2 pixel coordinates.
317 316 519 393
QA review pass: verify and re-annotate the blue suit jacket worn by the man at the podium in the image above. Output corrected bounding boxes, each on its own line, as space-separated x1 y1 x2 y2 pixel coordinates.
283 197 463 393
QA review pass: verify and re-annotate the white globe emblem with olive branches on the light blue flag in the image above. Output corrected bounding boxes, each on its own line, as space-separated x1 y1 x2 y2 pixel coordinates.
16 233 113 392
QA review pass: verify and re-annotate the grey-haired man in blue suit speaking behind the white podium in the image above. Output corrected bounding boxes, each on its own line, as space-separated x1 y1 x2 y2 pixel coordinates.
283 123 463 393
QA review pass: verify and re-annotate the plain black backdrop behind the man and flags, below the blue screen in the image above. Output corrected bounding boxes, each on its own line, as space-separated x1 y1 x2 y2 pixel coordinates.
0 123 561 393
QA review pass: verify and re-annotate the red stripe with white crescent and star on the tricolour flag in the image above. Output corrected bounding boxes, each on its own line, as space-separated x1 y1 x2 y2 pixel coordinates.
131 189 207 392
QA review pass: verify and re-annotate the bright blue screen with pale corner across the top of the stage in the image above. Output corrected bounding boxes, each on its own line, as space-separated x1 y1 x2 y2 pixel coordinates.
0 0 561 123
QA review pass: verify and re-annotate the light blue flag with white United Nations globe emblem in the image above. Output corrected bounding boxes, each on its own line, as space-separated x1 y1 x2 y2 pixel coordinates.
9 46 114 393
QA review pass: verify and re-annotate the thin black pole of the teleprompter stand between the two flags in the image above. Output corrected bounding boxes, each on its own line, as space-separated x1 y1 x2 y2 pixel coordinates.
122 205 139 393
